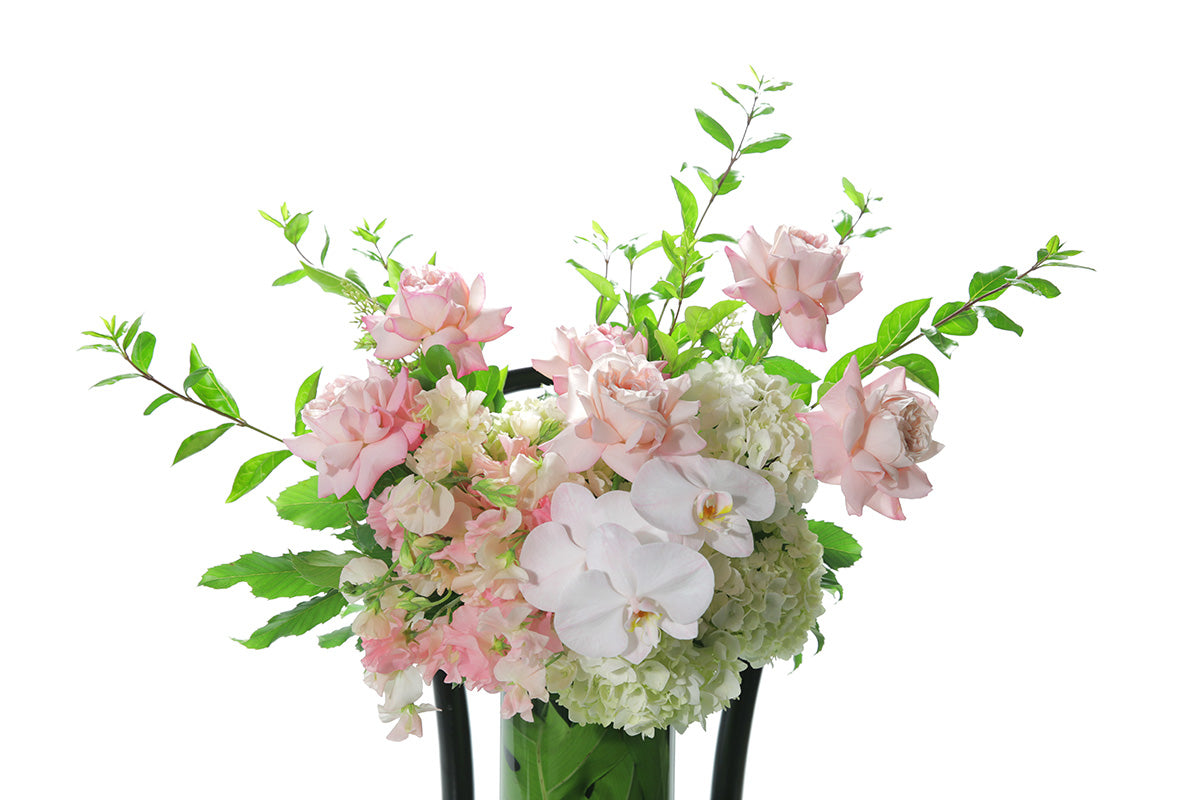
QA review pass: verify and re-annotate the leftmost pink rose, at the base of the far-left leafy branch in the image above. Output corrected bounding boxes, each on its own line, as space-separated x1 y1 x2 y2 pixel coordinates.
283 363 425 499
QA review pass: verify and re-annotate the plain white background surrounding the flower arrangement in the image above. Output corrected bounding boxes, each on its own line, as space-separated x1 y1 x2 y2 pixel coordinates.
0 1 1200 800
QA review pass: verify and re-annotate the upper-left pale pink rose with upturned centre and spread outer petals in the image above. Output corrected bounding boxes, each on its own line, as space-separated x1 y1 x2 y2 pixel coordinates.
362 264 512 377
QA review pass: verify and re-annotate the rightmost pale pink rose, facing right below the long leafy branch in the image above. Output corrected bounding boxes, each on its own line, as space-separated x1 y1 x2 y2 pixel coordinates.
798 359 942 519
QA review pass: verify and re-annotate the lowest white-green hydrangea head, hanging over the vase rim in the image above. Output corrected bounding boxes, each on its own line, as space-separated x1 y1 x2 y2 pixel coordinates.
547 631 745 736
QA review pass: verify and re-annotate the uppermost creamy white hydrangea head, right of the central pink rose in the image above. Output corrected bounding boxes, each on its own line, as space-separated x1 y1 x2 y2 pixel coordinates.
684 357 817 522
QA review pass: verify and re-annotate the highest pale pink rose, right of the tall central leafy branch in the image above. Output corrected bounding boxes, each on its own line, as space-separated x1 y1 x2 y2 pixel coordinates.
725 225 863 353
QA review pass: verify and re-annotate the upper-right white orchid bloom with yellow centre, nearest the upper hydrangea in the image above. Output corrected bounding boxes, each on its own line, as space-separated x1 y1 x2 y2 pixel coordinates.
630 456 775 558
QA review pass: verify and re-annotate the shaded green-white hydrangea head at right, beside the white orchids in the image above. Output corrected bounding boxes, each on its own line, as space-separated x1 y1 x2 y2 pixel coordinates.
701 515 826 667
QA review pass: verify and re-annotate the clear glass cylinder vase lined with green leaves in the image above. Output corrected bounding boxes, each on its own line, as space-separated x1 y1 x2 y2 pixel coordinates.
500 700 674 800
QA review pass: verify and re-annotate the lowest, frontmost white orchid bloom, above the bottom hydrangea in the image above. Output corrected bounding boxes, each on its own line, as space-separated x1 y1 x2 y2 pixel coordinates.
554 523 715 663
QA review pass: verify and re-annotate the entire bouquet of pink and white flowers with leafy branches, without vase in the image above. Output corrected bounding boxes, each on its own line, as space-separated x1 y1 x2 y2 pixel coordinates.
77 73 1087 796
